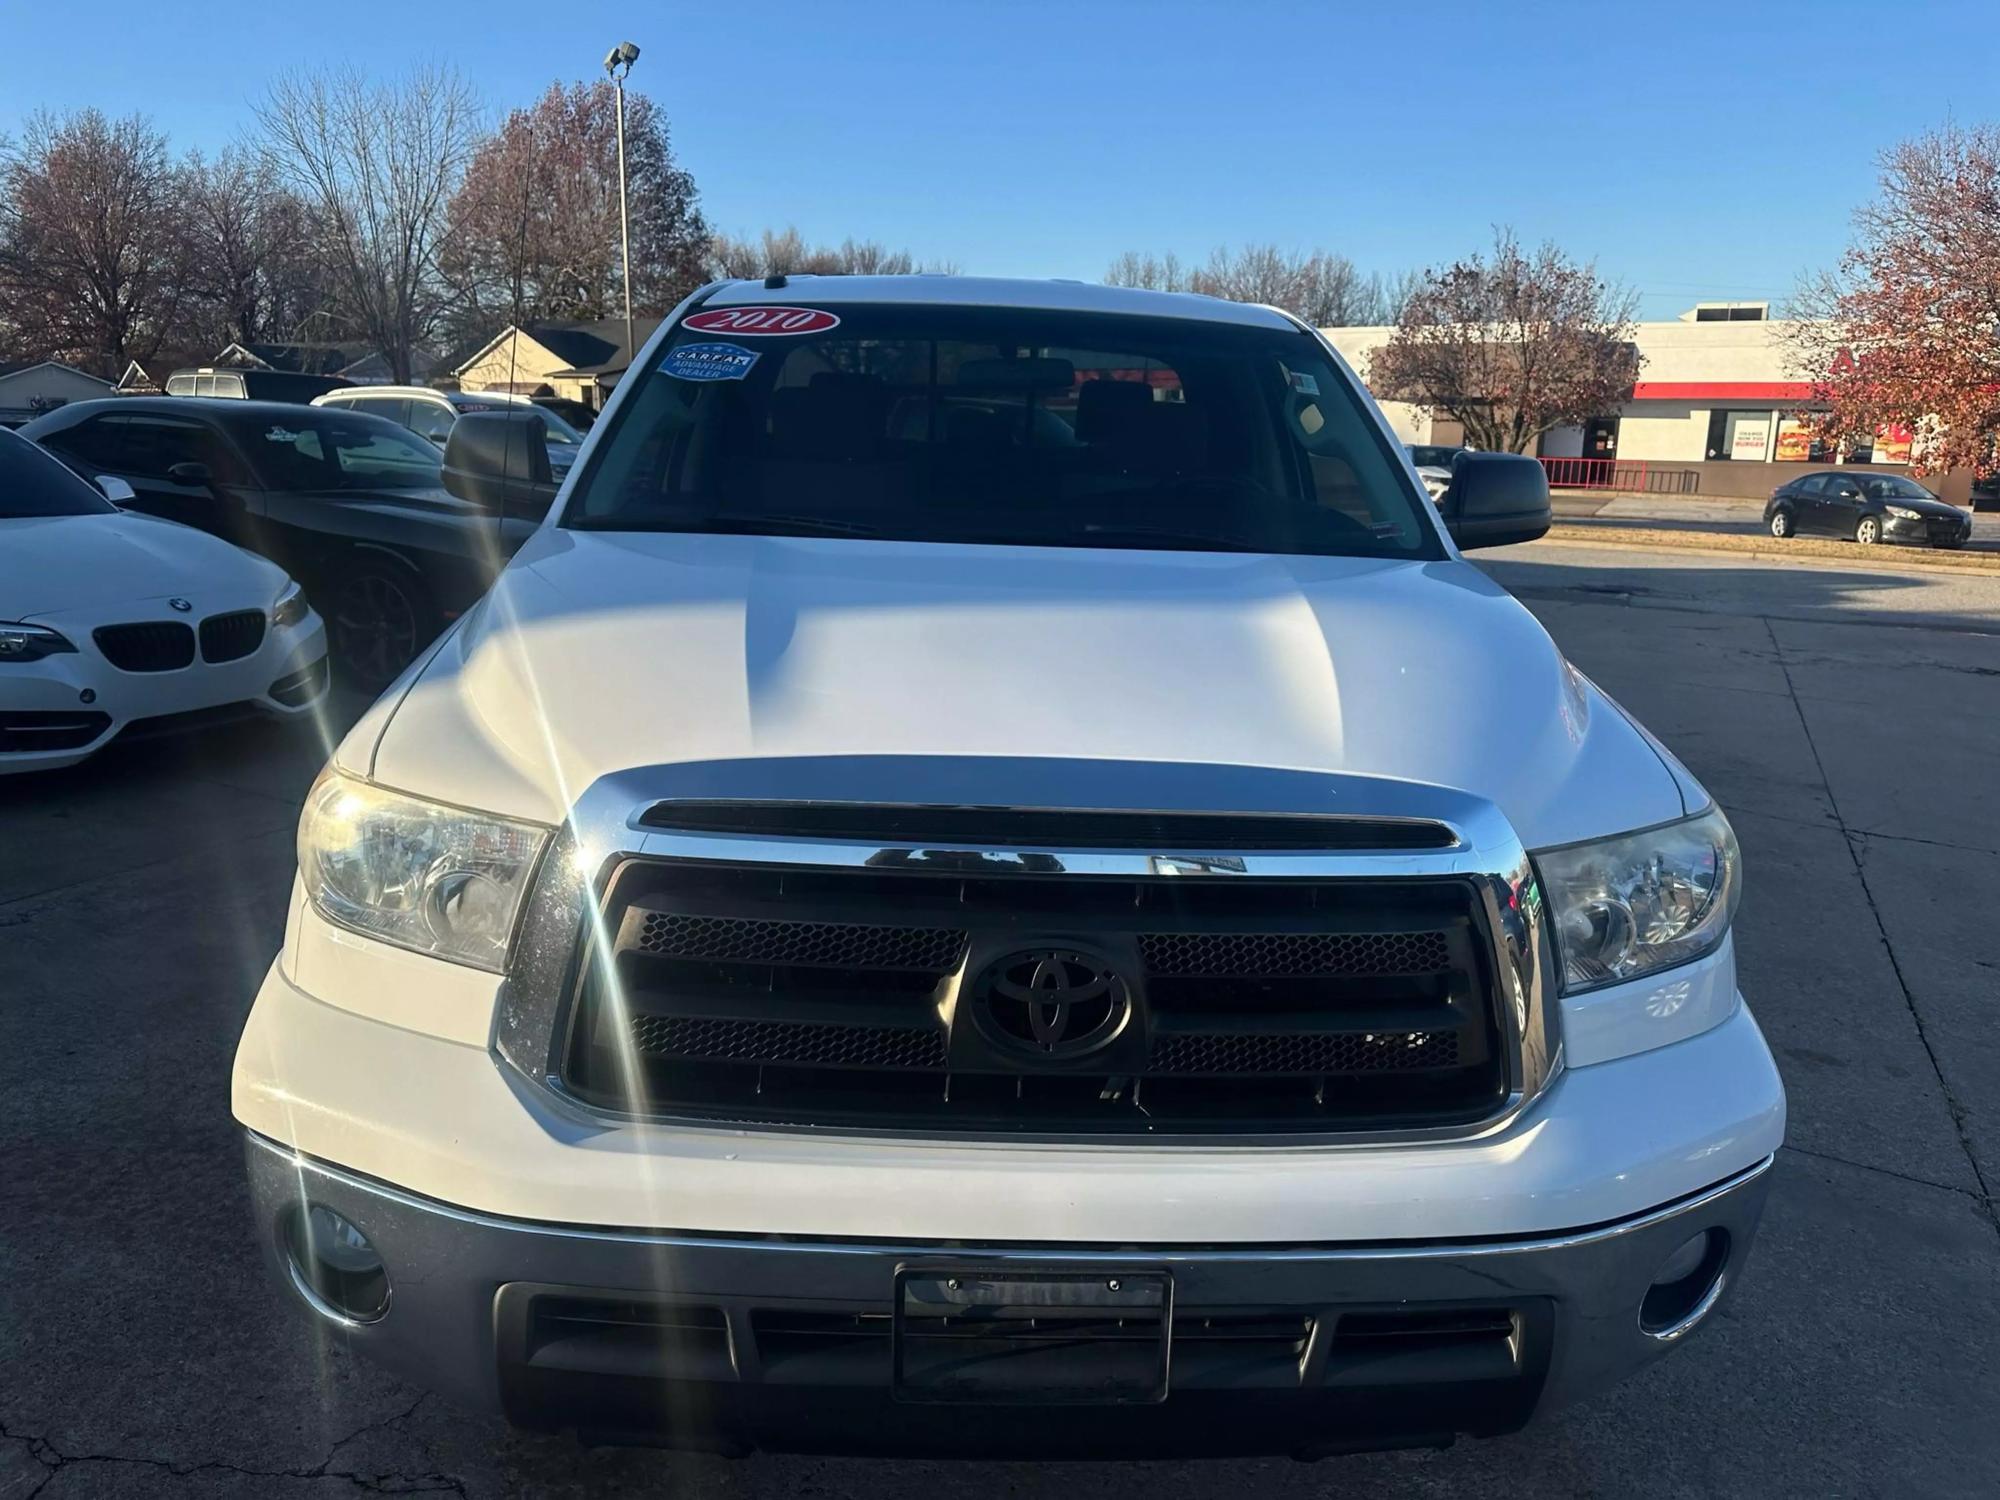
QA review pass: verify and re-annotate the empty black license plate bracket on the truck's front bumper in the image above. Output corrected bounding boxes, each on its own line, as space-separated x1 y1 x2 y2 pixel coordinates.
890 1266 1174 1406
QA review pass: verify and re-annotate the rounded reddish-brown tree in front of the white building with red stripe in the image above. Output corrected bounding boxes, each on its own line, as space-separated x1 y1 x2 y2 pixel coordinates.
1368 228 1640 454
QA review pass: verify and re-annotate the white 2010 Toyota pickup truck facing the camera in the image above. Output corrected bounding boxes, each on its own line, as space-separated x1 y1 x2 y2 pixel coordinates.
234 276 1784 1456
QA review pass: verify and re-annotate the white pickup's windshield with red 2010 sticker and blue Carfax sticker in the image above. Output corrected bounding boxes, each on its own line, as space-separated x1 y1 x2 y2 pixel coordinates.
564 306 1442 558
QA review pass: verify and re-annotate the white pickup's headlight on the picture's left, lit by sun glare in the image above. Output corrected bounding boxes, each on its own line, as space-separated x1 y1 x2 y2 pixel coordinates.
298 768 548 974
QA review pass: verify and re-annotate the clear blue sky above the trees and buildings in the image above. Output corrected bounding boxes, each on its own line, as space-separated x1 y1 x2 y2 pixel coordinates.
0 0 1996 318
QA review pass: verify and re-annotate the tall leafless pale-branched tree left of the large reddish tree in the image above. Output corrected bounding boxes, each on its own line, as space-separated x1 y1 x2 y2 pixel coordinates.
256 66 478 380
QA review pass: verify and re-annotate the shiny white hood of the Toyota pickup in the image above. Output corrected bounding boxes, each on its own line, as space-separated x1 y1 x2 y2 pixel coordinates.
356 528 1684 848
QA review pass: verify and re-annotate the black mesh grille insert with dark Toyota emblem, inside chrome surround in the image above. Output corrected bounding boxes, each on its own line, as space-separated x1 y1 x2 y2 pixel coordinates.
558 858 1506 1136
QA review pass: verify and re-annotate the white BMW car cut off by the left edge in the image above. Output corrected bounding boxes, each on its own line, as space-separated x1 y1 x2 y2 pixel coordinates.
0 430 328 774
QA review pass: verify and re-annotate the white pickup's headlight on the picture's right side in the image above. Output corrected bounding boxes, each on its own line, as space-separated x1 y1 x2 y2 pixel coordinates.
1534 808 1742 994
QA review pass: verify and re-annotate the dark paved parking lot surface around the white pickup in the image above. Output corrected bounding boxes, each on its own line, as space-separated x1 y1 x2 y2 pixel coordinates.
0 546 2000 1500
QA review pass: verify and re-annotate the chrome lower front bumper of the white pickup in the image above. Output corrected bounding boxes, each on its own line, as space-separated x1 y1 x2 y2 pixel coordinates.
246 1132 1770 1458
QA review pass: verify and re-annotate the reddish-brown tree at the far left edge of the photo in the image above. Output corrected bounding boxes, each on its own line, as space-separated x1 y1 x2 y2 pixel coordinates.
0 110 188 376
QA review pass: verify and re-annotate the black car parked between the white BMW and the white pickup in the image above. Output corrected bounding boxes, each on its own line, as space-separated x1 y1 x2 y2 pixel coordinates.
22 396 552 688
